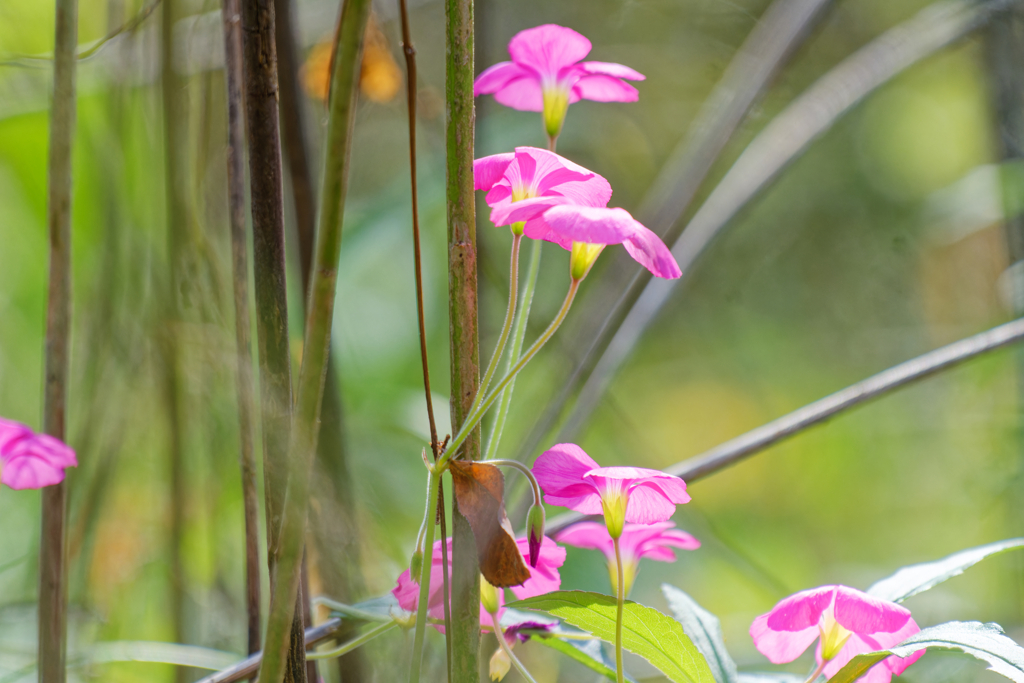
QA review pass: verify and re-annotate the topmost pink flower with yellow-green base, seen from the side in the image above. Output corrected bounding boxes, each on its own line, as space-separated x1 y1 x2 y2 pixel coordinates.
473 24 644 137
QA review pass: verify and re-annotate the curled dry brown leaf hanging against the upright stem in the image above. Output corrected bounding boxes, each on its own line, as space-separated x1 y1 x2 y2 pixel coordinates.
449 460 529 588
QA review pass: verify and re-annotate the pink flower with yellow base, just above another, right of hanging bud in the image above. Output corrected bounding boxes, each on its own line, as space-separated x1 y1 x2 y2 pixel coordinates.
534 443 690 538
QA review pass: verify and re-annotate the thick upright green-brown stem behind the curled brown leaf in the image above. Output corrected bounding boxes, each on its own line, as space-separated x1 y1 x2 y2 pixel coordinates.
442 0 480 683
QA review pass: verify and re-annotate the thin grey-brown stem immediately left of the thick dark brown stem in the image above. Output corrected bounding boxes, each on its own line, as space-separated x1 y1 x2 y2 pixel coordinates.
222 0 260 654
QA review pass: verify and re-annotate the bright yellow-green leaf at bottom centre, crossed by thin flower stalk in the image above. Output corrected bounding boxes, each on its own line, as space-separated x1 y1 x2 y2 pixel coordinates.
509 591 715 683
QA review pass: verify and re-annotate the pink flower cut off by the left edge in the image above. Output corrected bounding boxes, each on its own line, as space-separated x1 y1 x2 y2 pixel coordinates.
0 418 78 488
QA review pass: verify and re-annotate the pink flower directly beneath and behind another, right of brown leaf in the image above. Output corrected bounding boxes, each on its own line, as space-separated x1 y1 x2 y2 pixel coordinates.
558 521 700 594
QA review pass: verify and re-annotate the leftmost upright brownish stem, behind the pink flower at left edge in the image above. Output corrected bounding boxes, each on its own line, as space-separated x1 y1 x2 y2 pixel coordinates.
39 0 78 683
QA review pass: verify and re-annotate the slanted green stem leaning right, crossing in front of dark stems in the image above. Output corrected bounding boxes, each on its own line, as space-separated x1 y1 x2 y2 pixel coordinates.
259 0 370 683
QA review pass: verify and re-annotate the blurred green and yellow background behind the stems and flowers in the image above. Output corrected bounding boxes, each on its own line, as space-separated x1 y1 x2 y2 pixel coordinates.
0 0 1024 682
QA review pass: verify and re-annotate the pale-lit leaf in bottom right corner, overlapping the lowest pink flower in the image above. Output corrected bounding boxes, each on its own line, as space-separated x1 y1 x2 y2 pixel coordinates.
828 622 1024 683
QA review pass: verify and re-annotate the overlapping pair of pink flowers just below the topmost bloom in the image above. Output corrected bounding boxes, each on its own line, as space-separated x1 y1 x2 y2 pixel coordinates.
473 147 682 280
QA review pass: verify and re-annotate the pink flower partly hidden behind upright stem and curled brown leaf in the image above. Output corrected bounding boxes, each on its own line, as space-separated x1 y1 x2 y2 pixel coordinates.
391 537 565 627
